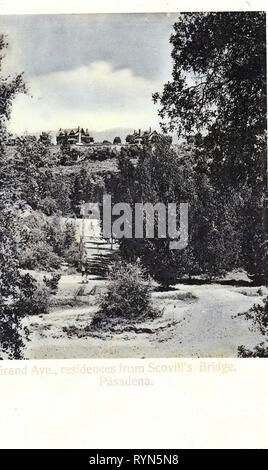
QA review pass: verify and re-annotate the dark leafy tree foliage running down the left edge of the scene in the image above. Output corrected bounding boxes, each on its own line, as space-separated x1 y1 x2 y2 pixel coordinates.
0 35 50 359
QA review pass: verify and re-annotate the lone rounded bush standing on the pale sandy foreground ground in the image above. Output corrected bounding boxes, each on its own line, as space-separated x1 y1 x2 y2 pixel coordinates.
91 262 160 327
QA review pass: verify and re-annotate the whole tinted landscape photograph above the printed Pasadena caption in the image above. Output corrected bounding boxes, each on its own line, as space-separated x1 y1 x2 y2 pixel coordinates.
0 11 268 360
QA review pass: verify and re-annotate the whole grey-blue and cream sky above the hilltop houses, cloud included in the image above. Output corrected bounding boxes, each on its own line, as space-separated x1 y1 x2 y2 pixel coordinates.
0 13 178 134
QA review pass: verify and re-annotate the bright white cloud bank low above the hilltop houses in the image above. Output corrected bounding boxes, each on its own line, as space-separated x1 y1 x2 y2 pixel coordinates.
10 61 162 133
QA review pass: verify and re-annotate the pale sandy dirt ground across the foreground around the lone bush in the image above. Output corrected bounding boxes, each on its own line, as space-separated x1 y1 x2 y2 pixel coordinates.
24 276 263 359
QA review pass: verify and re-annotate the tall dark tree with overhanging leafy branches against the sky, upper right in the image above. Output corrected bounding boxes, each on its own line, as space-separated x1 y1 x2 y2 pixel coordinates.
154 12 266 186
